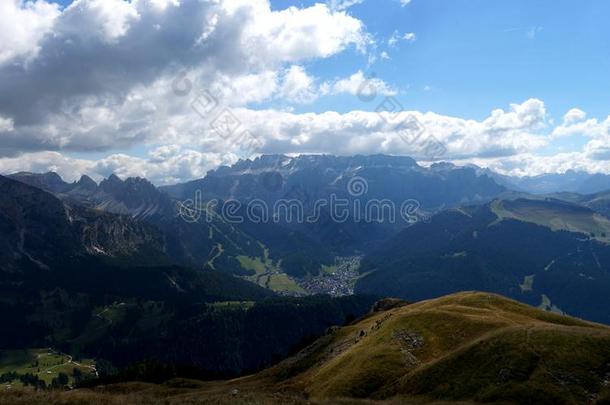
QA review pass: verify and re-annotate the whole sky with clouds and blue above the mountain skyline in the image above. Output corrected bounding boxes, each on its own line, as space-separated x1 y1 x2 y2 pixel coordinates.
0 0 610 184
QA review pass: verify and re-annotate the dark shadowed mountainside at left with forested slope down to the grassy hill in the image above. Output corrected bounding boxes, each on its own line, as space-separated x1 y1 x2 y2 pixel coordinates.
0 177 380 381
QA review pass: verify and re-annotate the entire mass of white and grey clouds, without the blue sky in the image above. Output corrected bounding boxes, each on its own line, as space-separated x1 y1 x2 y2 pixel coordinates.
0 0 610 184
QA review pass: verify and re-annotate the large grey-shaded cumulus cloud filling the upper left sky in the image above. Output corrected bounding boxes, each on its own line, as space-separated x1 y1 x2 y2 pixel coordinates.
0 0 370 153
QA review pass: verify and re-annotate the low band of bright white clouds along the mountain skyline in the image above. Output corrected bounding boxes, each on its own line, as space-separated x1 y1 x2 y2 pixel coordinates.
0 97 610 184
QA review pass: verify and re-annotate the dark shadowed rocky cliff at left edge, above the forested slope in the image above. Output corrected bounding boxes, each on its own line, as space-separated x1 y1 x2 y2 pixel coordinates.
0 177 164 272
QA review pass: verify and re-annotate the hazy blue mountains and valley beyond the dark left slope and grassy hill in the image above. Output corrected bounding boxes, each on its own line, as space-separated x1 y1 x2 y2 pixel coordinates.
10 155 610 306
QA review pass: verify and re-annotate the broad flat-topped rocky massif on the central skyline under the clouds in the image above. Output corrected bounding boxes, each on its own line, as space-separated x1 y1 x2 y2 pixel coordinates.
161 155 505 210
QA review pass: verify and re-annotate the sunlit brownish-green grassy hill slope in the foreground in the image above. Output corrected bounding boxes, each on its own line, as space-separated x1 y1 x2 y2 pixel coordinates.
5 292 610 404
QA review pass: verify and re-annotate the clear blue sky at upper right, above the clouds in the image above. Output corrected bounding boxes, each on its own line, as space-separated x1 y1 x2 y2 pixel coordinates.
48 0 610 119
